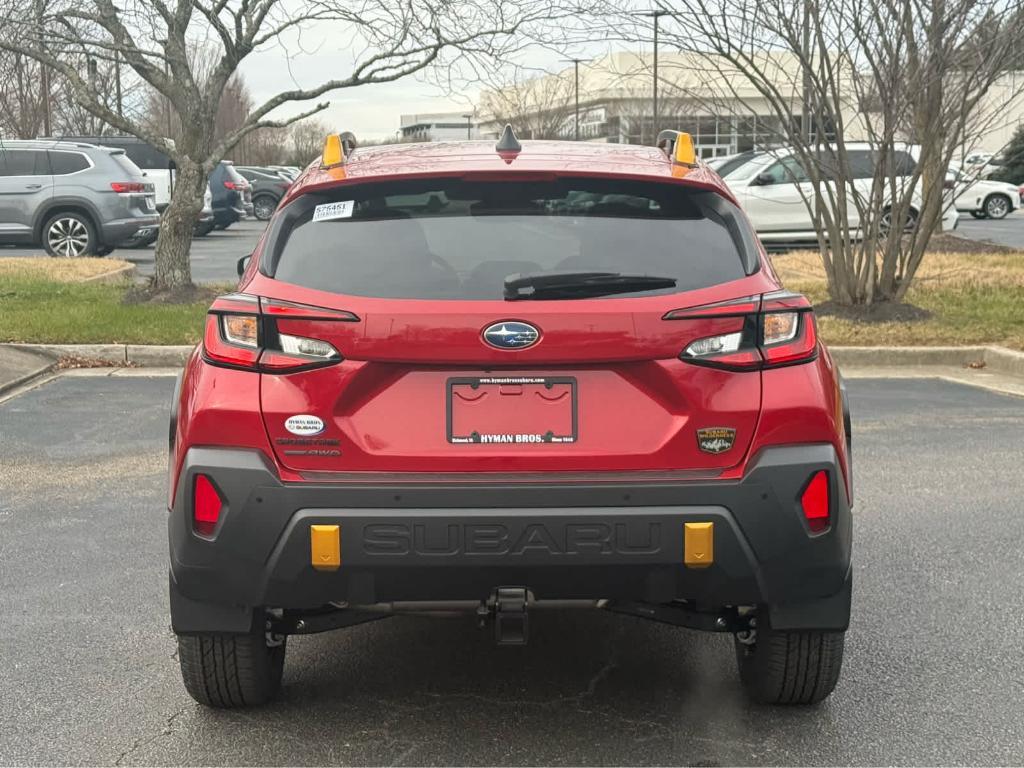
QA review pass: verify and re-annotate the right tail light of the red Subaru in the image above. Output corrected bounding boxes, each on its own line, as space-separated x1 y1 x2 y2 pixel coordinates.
665 291 818 371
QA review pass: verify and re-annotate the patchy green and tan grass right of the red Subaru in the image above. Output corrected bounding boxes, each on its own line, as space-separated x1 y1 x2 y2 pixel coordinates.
772 252 1024 349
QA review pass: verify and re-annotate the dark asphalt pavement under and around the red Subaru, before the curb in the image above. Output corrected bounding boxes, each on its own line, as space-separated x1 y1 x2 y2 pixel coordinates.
0 372 1024 766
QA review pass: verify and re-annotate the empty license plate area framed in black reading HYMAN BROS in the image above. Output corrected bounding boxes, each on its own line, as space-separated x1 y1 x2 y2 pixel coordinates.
446 376 578 445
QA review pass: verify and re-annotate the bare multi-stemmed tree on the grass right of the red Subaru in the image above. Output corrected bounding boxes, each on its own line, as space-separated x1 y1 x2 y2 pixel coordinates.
630 0 1022 304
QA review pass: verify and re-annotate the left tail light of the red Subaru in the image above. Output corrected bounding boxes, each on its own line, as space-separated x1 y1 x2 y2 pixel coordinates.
203 293 359 373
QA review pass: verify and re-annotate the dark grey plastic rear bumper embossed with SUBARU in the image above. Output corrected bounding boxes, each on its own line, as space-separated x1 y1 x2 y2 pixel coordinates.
169 445 851 632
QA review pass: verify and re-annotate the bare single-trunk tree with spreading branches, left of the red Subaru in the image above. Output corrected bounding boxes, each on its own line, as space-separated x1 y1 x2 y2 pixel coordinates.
0 0 575 290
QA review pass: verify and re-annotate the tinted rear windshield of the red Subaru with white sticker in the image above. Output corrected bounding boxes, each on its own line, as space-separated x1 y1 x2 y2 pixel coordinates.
263 178 757 299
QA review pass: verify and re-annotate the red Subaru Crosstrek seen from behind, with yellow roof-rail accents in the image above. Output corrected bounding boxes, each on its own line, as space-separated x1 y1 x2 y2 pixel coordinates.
169 128 852 707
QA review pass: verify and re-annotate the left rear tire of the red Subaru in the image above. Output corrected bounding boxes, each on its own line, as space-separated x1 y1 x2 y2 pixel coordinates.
178 632 287 709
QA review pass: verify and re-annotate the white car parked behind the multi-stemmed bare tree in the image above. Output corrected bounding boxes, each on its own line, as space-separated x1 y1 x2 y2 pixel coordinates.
723 143 958 246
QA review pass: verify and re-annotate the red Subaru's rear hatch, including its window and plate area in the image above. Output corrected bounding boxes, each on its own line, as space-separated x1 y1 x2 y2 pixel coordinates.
247 177 768 473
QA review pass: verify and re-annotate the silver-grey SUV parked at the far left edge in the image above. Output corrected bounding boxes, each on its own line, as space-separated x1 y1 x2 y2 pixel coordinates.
0 139 160 256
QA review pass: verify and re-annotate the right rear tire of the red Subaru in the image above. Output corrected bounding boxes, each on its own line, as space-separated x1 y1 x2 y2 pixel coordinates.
735 629 846 705
